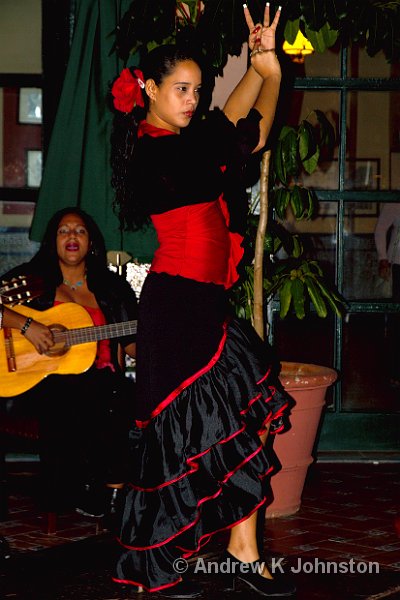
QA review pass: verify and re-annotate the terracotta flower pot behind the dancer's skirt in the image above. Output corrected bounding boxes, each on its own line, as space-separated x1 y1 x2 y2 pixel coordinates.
266 362 337 518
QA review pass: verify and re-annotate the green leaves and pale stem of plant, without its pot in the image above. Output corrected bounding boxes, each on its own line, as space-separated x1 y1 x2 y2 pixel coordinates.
232 110 344 338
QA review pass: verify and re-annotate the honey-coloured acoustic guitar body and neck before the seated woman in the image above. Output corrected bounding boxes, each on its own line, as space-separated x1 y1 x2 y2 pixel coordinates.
0 302 137 397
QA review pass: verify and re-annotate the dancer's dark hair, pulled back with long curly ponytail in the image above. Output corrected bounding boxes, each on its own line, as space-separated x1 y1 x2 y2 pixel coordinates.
111 44 203 231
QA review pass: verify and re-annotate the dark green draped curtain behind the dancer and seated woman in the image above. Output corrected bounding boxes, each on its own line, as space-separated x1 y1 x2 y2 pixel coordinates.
30 0 157 262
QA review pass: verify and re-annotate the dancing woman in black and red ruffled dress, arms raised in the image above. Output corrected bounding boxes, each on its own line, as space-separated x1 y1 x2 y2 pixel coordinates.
112 4 295 598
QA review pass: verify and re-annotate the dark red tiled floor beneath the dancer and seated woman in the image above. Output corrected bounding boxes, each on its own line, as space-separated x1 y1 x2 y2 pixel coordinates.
0 462 400 600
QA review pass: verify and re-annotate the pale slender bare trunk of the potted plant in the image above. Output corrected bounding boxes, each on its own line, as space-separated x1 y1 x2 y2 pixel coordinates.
254 150 271 339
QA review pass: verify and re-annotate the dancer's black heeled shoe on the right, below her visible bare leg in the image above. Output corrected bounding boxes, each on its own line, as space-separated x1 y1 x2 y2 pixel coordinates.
220 551 296 598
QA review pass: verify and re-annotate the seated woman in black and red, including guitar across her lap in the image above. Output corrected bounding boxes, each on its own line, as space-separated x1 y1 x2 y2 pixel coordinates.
0 207 137 528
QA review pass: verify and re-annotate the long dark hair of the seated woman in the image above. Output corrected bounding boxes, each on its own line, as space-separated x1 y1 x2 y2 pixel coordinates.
30 206 107 289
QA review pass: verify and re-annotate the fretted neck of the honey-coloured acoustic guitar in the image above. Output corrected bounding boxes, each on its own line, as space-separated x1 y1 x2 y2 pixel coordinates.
53 321 137 346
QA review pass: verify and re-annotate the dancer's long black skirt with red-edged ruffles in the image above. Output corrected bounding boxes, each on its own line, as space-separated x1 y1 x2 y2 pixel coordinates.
114 274 292 591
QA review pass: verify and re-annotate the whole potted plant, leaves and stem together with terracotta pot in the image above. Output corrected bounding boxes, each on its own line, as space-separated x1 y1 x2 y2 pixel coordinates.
233 115 344 517
